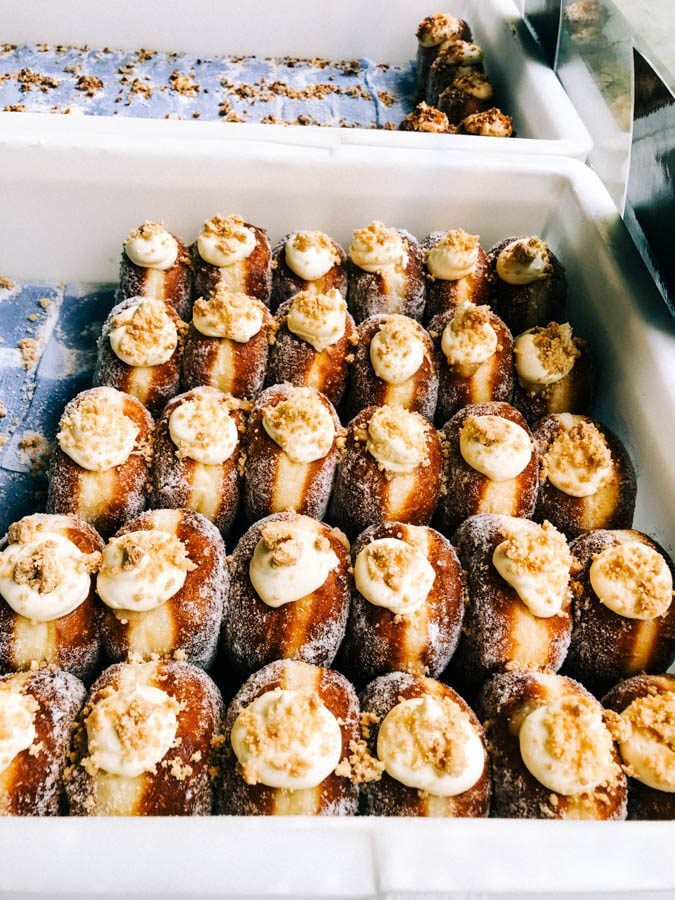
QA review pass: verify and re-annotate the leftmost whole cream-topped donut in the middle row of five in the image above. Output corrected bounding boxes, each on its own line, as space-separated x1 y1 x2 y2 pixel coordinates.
47 387 154 537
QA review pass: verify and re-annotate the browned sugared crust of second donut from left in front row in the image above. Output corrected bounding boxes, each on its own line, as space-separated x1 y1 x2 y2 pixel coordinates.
65 660 223 816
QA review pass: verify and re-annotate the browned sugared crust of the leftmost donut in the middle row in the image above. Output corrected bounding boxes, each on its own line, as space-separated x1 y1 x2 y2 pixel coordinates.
47 388 155 538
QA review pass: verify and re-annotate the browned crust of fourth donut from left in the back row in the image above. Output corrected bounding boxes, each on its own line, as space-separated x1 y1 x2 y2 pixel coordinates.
347 228 424 322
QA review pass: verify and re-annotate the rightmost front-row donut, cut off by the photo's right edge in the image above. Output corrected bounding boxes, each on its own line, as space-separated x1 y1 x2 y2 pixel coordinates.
602 675 675 820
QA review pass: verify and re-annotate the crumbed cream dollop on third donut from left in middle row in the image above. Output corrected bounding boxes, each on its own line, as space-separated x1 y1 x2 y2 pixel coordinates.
262 387 335 463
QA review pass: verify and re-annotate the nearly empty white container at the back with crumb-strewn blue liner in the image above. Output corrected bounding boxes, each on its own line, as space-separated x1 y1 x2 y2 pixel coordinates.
0 0 592 161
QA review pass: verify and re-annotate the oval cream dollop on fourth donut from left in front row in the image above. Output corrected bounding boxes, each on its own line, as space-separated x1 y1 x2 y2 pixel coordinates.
377 695 485 797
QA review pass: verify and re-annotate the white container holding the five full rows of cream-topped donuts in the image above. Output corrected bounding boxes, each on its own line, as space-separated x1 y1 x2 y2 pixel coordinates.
0 135 675 898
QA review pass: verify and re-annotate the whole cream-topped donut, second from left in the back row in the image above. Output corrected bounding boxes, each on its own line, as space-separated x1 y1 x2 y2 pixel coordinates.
192 215 272 306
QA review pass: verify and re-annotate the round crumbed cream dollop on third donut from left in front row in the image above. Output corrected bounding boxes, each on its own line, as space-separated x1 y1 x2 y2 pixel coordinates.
230 688 342 791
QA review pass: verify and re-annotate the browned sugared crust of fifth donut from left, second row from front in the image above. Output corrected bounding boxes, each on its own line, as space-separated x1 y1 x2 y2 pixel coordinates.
451 515 572 690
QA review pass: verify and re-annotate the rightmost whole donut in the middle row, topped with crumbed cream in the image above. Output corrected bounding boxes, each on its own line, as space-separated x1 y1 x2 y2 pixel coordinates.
534 413 637 538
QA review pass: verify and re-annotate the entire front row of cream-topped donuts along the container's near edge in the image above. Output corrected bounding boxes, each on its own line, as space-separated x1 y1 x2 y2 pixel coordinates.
0 660 675 820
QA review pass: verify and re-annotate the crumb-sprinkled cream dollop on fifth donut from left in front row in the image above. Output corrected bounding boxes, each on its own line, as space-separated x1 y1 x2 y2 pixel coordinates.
519 696 616 796
